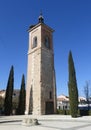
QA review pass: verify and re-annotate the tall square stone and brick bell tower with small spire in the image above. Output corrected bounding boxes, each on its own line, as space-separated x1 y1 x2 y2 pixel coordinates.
25 14 56 115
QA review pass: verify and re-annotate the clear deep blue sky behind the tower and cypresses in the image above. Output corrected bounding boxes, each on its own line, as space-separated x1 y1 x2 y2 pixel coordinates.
0 0 91 96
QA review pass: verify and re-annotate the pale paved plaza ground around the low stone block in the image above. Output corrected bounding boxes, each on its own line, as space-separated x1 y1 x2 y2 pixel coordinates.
0 115 91 130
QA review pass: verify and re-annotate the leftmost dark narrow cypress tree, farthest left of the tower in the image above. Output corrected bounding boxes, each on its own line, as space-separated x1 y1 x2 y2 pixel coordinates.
4 66 14 115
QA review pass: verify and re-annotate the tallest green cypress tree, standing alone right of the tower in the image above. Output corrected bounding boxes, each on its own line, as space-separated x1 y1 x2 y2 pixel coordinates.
68 51 78 117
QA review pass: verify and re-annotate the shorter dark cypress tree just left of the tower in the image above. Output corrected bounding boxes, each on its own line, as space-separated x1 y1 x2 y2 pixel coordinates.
17 74 25 115
